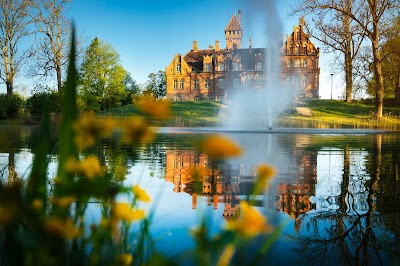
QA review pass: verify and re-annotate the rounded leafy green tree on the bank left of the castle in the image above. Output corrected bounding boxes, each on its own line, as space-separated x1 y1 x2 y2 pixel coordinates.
80 37 127 110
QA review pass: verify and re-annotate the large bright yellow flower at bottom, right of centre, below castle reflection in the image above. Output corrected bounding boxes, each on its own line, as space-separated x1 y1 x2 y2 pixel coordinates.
227 201 271 238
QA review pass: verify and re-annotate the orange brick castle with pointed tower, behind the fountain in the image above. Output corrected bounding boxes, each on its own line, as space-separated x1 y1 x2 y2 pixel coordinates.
166 10 320 101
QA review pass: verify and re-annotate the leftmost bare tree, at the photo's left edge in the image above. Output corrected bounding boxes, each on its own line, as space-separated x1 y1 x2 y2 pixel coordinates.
0 0 31 98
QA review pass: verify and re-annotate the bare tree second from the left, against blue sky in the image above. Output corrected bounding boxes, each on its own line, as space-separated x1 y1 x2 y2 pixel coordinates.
30 0 71 91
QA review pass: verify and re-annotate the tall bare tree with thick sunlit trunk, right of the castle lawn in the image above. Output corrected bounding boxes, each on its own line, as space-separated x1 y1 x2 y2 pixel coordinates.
290 0 398 120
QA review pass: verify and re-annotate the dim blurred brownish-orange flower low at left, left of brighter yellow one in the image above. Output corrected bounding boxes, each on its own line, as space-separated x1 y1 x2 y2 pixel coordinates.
44 217 79 239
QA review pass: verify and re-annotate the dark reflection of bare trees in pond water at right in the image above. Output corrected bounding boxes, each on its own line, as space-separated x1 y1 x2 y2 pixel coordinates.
288 135 400 265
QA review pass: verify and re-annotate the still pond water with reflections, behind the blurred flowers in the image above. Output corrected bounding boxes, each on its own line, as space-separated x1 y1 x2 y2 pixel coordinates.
0 127 400 265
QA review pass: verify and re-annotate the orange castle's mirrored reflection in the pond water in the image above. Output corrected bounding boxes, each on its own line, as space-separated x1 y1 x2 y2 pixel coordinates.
165 136 317 219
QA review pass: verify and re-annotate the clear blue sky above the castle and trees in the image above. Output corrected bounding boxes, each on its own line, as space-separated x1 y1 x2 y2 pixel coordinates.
1 0 336 97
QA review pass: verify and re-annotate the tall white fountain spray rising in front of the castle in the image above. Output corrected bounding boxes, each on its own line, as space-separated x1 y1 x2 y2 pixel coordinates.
222 0 297 131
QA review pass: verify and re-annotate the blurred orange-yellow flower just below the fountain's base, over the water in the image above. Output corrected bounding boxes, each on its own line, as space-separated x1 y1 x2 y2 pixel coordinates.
201 135 242 159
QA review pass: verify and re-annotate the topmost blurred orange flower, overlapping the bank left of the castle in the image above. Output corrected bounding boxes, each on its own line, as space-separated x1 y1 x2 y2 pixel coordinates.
137 96 171 120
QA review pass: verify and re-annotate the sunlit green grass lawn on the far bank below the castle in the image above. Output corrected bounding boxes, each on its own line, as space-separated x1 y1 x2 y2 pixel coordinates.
100 100 400 130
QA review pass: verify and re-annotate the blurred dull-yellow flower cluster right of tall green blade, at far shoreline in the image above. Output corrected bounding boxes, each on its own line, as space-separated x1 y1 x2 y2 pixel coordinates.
75 113 117 148
